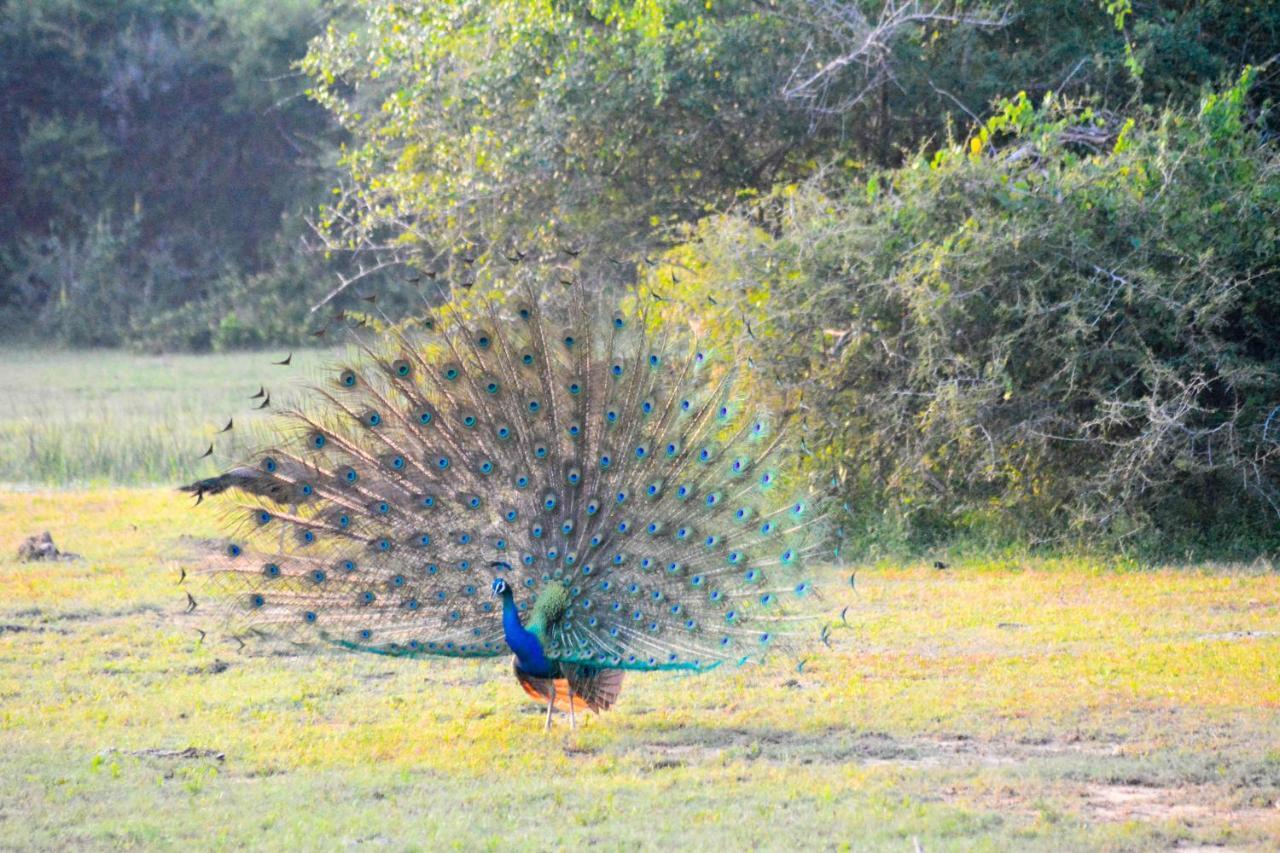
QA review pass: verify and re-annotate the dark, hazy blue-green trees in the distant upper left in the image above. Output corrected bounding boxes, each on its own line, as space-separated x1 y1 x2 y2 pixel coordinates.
0 0 333 346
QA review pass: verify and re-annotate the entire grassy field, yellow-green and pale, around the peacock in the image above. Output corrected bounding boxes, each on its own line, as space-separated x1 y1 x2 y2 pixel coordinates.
0 355 1280 850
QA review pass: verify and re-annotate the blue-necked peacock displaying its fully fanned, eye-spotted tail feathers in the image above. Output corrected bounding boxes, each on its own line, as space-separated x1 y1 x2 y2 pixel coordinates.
182 275 827 729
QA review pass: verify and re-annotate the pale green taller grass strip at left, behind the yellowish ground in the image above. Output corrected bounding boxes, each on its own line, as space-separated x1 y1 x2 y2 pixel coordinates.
0 348 340 485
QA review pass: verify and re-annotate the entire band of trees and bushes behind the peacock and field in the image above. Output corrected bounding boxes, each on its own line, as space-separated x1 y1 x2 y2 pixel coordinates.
0 0 1280 552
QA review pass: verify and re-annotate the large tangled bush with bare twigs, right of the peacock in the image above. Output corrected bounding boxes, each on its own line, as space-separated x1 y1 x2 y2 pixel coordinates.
668 74 1280 548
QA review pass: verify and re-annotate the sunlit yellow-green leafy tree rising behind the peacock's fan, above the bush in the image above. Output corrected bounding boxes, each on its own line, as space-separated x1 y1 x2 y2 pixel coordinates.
303 0 1280 289
